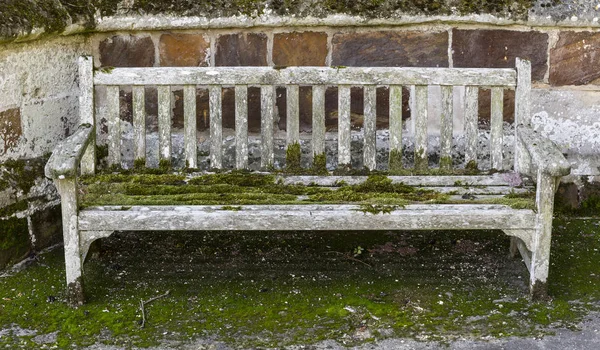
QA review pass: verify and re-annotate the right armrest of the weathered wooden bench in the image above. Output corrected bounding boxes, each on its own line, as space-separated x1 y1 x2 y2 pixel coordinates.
517 124 571 177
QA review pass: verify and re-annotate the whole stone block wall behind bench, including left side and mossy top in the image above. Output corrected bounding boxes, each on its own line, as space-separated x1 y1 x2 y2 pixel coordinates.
0 0 600 268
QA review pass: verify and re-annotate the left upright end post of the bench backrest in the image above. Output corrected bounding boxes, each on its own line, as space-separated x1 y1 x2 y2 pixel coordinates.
79 56 96 175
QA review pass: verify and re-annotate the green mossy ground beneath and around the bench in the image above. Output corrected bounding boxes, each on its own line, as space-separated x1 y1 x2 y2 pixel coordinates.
0 220 600 349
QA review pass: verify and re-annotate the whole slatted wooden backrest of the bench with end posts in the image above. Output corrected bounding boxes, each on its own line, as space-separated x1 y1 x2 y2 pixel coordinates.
79 57 531 173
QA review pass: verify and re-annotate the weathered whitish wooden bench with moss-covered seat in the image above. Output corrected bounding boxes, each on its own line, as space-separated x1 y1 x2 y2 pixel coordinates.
46 57 570 305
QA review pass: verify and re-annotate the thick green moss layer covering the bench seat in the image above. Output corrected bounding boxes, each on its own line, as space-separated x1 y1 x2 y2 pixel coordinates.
80 171 535 209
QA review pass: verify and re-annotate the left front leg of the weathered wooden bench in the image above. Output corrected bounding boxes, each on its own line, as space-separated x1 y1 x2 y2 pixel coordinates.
56 179 84 306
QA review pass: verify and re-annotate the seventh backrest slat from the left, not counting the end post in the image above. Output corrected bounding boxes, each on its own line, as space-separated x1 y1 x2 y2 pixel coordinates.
260 85 275 168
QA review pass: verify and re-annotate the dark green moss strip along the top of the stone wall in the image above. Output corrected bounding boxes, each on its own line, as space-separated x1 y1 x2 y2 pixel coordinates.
0 0 558 39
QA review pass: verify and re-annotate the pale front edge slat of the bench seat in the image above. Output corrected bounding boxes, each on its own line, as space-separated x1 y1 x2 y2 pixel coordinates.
79 205 535 231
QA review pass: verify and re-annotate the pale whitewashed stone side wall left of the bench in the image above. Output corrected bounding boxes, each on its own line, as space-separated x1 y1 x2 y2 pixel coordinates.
0 36 87 268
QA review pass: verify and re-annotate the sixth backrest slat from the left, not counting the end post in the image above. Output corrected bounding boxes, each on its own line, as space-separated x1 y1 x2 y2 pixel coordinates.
235 85 248 169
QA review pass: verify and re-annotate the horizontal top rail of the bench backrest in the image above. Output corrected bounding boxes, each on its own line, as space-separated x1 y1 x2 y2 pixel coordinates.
94 67 516 88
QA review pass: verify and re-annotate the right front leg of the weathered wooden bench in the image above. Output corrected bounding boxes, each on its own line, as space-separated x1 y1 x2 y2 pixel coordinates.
529 172 556 300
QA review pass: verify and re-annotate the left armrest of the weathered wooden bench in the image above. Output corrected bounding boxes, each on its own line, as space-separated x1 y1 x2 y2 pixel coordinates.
45 124 94 179
